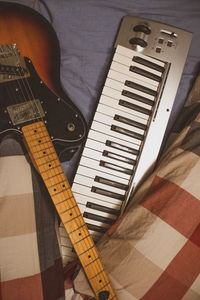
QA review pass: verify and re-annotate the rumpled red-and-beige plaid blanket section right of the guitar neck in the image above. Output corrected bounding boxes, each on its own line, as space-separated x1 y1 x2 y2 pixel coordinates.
75 76 200 300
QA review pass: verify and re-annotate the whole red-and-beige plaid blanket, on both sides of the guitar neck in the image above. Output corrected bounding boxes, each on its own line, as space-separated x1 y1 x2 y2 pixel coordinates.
0 71 200 300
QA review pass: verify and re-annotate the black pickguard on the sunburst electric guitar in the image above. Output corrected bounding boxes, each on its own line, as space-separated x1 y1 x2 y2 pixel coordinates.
0 58 87 161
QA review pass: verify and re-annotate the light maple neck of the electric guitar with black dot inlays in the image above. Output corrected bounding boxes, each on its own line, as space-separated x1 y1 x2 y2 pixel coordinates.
22 121 117 300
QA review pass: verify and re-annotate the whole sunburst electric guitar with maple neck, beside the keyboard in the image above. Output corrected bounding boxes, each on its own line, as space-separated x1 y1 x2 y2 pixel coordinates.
0 2 117 300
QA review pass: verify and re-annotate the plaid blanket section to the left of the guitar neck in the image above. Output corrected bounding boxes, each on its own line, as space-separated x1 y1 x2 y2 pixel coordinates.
0 137 64 300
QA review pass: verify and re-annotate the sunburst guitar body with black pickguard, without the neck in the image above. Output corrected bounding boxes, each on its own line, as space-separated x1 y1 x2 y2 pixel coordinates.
0 2 87 160
